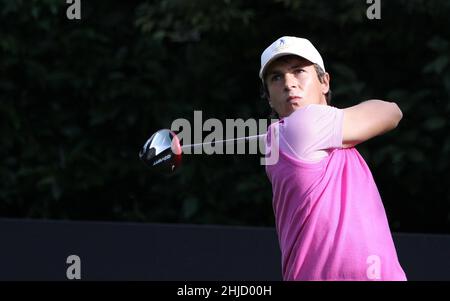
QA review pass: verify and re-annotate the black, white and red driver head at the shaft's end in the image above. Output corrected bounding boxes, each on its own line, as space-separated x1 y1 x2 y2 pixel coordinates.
139 129 181 172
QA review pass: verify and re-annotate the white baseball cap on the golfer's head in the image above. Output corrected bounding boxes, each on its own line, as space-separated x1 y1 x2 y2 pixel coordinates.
259 36 325 81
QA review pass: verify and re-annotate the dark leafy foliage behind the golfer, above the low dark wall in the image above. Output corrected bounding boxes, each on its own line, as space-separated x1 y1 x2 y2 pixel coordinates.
0 0 450 233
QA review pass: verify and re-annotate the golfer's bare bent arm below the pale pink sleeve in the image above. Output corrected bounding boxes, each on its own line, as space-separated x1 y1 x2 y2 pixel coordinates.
342 99 403 148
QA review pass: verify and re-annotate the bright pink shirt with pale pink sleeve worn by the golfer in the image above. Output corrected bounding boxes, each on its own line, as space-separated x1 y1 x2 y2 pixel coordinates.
266 105 406 280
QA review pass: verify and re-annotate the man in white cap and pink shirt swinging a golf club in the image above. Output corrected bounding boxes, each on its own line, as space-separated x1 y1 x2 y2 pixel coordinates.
259 36 406 281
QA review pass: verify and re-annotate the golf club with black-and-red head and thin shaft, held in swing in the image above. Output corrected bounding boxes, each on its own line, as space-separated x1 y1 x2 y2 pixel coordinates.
139 129 266 171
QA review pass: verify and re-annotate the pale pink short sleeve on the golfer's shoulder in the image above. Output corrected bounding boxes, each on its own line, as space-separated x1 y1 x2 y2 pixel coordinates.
280 104 344 161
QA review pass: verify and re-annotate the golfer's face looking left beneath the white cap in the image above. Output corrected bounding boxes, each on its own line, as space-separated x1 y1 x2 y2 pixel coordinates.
264 55 330 118
